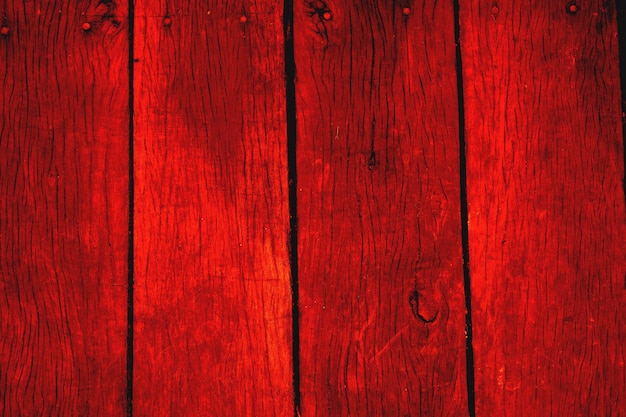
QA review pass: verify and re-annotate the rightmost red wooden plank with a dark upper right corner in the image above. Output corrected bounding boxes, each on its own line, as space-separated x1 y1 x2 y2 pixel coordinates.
460 0 626 417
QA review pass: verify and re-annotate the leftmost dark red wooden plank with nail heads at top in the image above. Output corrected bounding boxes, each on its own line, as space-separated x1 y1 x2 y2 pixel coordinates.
0 1 129 416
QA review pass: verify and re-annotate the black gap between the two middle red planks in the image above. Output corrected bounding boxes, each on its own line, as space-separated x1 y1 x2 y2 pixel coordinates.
283 0 300 417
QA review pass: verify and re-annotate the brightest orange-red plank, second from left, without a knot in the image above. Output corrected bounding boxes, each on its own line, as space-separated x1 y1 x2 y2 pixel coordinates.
134 0 293 417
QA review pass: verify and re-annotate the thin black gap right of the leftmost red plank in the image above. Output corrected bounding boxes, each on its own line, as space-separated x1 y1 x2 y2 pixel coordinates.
126 0 135 417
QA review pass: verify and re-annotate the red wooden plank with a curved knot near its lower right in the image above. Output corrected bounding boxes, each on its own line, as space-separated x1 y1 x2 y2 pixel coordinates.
294 0 468 416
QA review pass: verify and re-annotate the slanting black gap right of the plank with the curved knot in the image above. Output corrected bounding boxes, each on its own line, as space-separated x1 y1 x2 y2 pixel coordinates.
453 0 476 417
